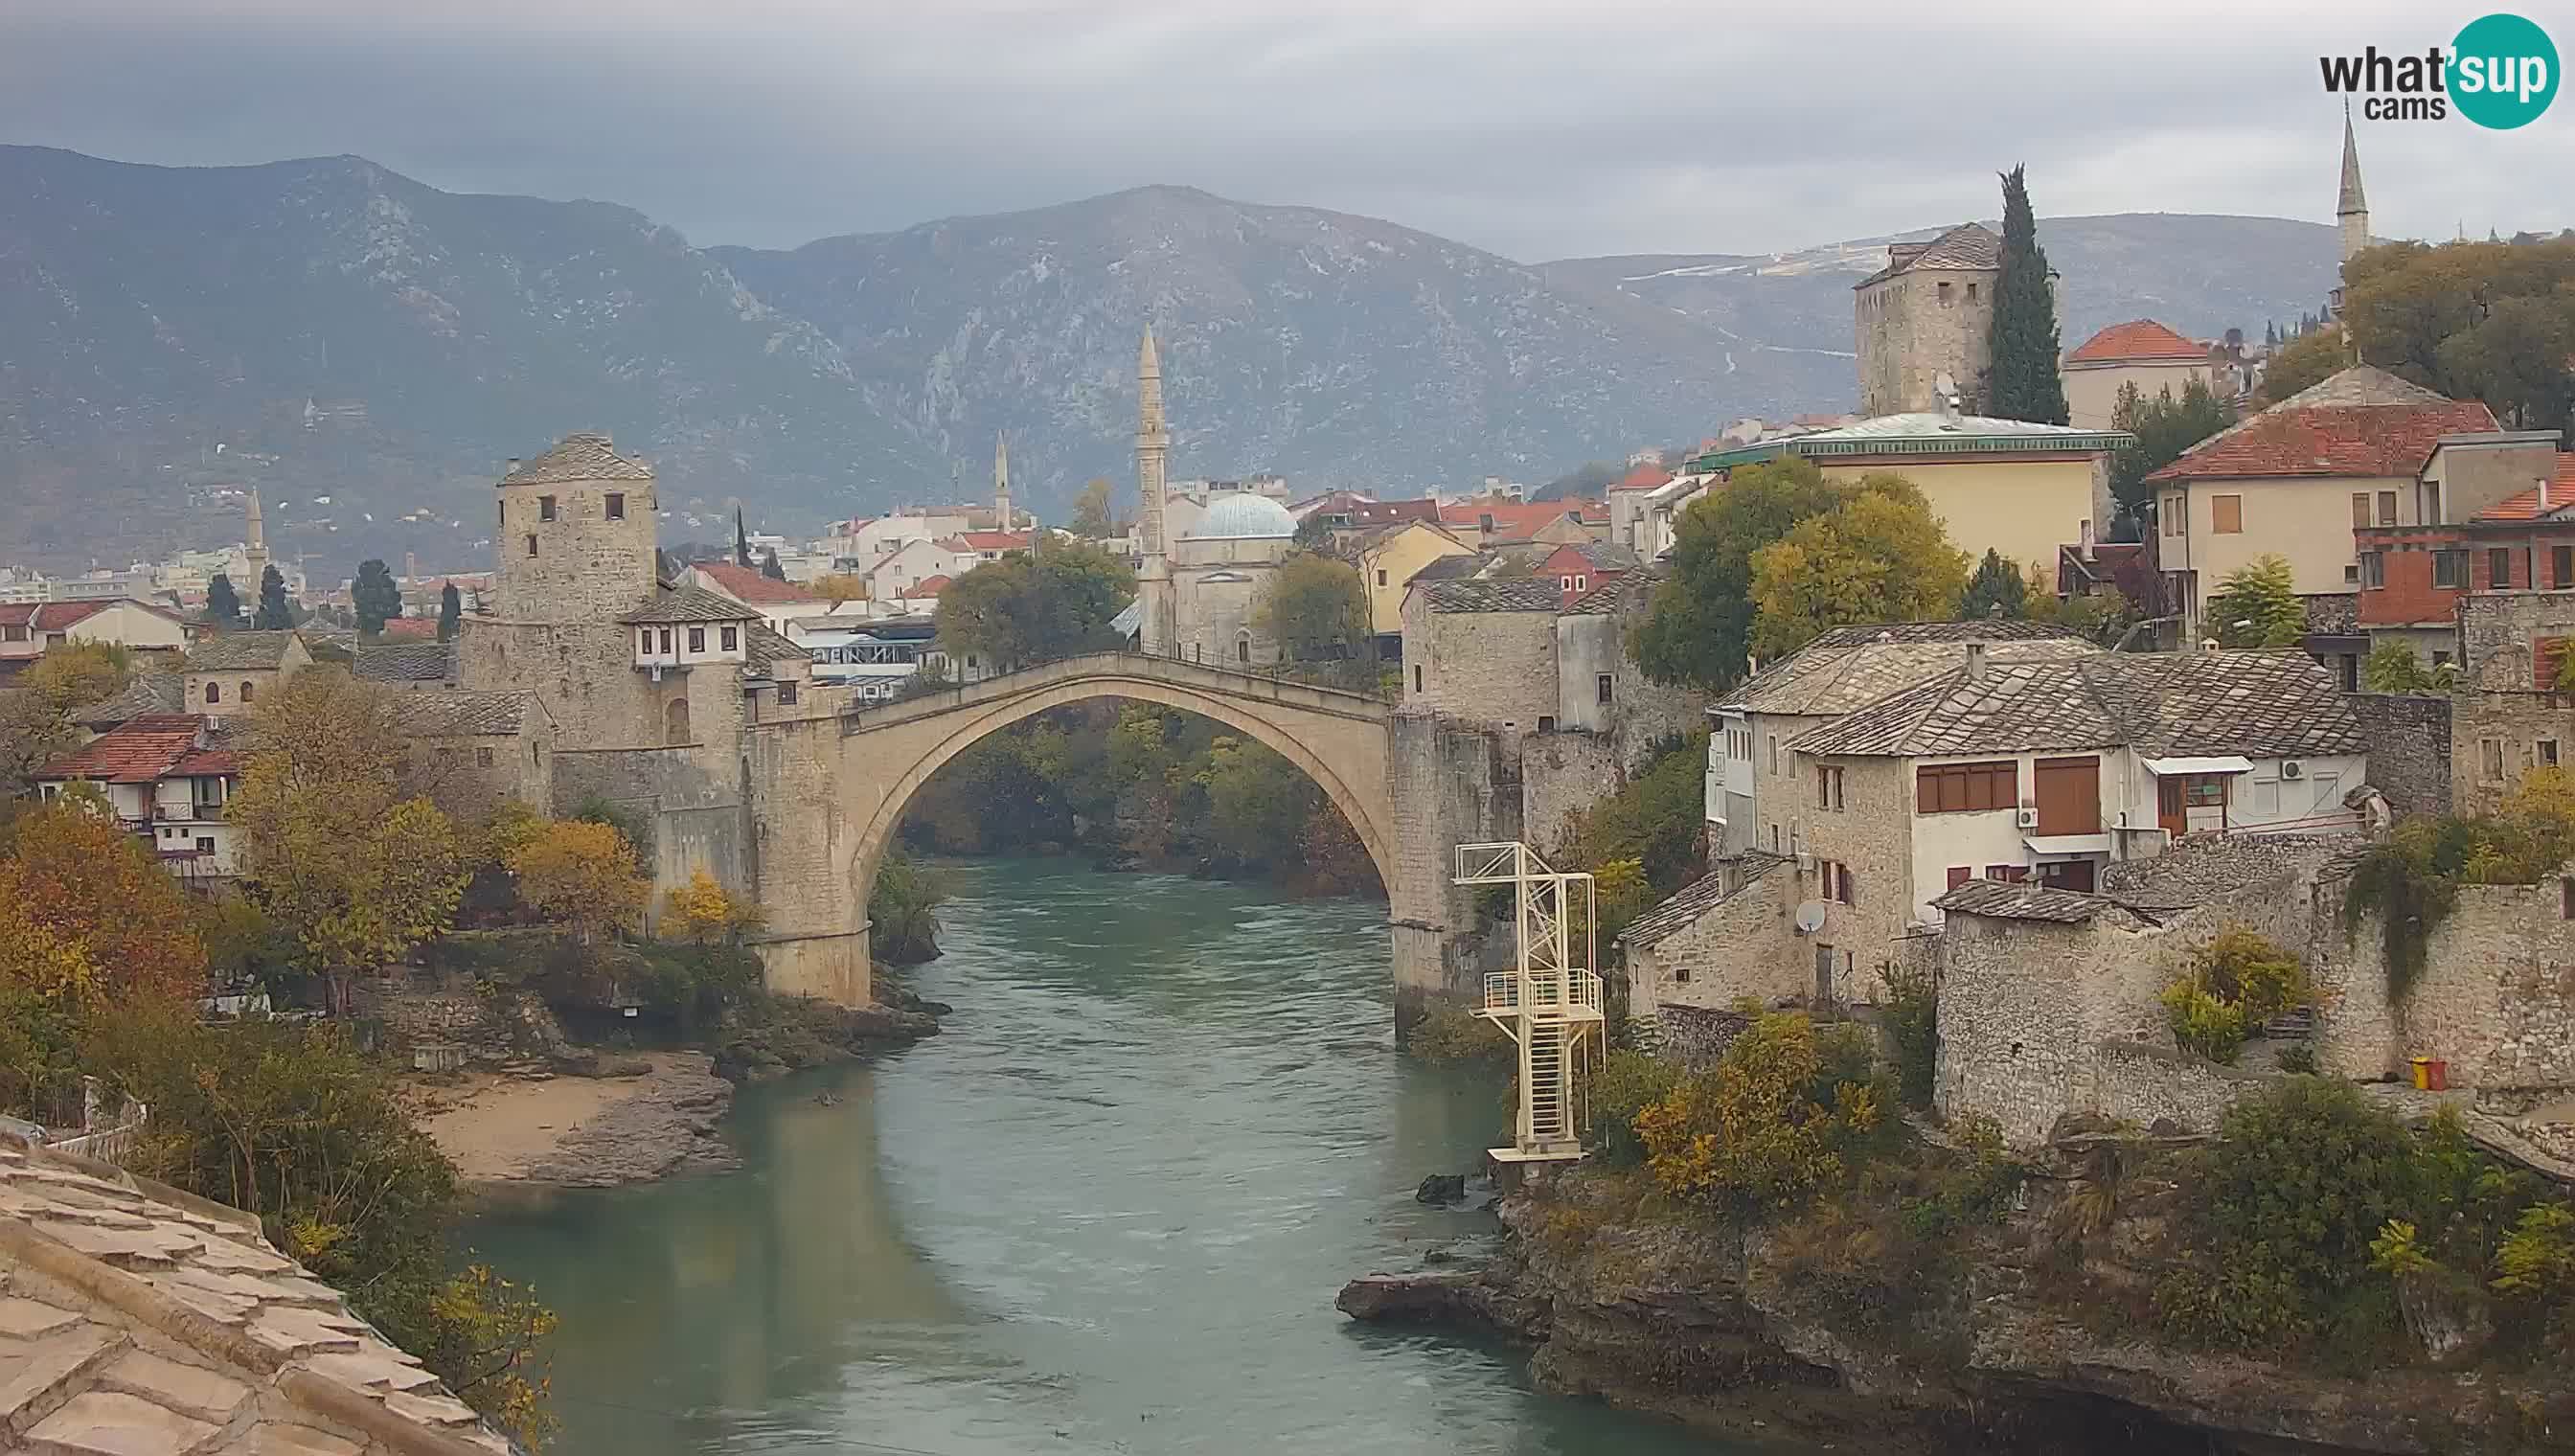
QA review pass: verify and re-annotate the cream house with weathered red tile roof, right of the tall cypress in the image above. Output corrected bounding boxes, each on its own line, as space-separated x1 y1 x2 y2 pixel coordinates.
2153 363 2495 642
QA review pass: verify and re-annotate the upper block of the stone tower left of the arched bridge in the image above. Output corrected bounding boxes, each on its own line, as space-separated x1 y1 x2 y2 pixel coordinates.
491 433 656 624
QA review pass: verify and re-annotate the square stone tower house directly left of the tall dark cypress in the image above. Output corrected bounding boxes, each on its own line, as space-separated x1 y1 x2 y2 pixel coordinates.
1852 221 2008 415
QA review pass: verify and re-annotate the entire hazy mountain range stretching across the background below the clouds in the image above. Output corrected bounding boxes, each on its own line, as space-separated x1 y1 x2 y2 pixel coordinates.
0 147 2333 575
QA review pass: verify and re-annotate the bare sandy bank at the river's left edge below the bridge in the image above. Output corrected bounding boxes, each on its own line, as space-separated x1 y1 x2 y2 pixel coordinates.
412 1052 734 1188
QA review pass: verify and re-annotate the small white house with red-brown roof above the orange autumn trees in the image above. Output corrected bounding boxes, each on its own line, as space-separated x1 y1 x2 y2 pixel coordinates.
29 714 242 878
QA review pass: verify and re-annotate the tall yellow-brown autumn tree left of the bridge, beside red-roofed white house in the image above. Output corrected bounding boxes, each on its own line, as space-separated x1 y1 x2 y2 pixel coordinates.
227 668 467 1012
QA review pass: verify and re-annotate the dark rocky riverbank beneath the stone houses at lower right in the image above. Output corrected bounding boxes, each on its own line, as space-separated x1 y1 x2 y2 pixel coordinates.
1339 1154 2575 1456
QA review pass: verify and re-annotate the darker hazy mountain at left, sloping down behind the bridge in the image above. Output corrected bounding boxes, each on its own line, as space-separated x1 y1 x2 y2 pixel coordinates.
0 147 917 570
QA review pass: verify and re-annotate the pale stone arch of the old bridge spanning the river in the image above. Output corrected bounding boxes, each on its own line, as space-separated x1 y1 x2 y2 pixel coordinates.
809 652 1408 997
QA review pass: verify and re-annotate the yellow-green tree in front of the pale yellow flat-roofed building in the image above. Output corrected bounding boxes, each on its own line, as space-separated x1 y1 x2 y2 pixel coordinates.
1751 474 1968 657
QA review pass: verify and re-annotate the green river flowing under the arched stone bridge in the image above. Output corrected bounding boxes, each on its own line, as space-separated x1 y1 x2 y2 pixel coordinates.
467 861 1782 1456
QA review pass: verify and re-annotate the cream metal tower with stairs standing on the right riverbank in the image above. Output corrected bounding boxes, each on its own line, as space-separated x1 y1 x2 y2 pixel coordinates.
1457 840 1605 1162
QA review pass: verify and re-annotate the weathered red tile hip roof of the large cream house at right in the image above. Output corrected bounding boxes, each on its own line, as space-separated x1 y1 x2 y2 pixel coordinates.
2145 363 2495 479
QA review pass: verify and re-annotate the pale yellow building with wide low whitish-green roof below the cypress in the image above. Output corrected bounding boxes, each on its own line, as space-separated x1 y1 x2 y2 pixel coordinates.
1684 410 2130 584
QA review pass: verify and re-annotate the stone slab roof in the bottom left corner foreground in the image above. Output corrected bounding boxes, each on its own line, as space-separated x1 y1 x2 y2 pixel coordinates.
0 1139 513 1456
